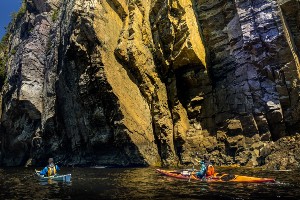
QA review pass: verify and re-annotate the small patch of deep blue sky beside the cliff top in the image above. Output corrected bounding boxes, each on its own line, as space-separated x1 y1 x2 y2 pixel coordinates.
0 0 22 39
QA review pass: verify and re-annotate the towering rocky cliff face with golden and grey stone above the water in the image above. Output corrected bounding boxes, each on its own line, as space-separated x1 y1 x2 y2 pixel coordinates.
0 0 300 168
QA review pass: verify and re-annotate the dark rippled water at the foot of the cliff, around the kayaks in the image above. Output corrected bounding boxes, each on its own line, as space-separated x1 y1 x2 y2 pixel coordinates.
0 167 300 200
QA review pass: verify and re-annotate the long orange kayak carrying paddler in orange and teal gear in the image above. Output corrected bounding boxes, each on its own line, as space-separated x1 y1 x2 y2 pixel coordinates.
156 169 275 183
